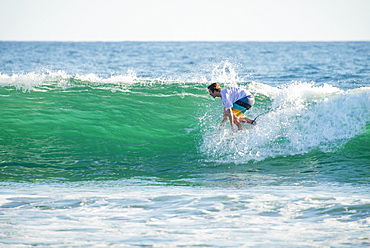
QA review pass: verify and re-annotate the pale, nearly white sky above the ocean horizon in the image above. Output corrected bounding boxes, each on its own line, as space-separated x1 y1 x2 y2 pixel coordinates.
0 0 370 41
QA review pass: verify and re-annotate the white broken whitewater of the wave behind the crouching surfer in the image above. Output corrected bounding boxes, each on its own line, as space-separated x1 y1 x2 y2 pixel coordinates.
201 82 370 163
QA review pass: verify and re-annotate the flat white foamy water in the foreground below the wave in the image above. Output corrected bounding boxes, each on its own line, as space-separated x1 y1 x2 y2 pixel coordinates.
0 181 370 247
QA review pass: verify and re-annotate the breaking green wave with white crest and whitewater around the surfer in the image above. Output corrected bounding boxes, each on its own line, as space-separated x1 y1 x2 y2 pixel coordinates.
0 77 370 183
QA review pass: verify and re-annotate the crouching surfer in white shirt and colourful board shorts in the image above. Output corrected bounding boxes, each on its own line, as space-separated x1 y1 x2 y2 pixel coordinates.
208 83 256 131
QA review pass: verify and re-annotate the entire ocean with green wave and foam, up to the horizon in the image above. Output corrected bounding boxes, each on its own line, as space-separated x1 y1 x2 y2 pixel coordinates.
0 42 370 247
